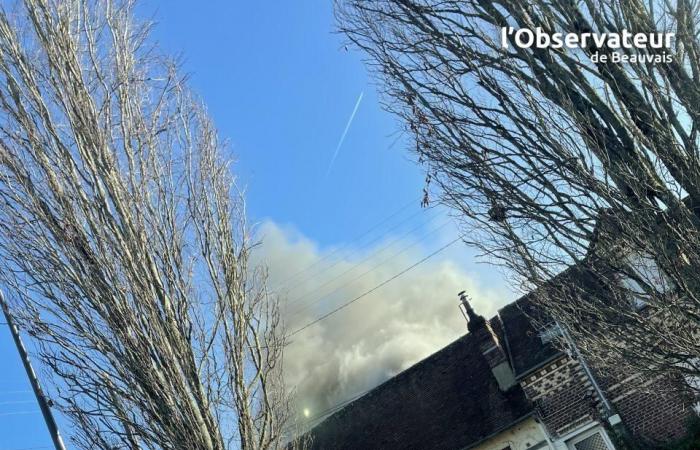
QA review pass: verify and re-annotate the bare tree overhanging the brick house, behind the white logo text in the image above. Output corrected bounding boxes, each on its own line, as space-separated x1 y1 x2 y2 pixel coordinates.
337 0 700 388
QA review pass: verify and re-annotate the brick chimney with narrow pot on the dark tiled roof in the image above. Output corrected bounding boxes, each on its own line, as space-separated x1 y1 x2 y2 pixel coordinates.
459 291 515 391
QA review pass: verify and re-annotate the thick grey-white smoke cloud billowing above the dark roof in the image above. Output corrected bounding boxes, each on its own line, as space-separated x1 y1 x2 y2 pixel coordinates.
253 222 513 426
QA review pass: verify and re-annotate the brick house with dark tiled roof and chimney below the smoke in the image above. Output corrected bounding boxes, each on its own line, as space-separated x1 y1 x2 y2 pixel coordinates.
309 280 695 450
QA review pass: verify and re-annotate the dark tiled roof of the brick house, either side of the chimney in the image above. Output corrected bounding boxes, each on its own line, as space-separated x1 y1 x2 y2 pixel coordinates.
300 299 540 450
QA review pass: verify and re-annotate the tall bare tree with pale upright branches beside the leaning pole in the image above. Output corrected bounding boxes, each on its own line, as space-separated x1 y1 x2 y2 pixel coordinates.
0 0 300 449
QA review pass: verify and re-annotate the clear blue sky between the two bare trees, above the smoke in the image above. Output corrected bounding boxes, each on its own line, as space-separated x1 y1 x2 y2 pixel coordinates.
143 0 423 245
